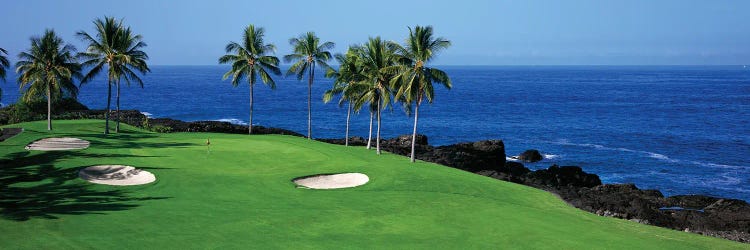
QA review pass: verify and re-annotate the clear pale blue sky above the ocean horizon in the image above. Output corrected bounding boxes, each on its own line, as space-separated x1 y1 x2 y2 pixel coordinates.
0 0 750 65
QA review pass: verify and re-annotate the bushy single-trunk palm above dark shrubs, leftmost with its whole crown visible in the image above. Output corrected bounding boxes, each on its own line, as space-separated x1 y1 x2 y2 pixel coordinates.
16 29 82 130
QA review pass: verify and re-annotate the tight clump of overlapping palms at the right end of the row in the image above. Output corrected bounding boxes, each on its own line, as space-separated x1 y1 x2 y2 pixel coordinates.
323 26 452 162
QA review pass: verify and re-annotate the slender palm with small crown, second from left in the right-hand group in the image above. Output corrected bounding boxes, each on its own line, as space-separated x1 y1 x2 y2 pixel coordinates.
284 32 334 140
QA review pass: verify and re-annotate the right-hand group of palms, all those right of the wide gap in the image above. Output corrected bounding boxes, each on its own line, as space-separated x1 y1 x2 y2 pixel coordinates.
219 25 451 162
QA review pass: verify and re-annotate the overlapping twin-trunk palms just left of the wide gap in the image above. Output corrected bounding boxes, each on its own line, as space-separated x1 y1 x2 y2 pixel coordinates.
76 17 150 134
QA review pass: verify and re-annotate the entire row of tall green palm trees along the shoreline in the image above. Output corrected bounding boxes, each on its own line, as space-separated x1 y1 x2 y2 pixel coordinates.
0 17 451 162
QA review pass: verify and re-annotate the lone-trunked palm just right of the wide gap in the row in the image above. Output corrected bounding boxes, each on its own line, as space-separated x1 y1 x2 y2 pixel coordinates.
219 24 281 134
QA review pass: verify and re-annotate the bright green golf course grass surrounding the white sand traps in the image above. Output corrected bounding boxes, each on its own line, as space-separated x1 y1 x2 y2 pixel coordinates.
0 120 750 249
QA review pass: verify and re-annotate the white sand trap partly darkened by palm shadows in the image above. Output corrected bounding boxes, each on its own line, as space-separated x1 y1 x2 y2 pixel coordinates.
78 165 156 186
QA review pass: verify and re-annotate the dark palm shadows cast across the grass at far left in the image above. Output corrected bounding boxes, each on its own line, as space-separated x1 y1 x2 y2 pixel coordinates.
0 151 168 221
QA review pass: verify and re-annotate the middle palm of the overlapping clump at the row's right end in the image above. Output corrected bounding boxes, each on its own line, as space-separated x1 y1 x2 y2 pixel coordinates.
360 37 398 154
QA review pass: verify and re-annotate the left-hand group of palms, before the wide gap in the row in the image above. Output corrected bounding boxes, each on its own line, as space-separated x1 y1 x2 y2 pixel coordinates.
6 17 150 134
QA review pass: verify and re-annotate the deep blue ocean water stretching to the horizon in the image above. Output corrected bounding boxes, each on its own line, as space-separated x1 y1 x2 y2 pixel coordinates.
0 66 750 201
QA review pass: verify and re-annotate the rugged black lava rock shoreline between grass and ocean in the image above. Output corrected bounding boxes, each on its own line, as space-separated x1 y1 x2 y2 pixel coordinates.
4 110 750 243
